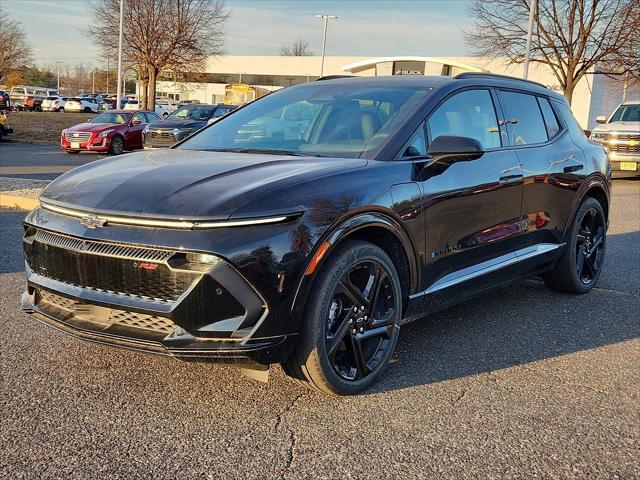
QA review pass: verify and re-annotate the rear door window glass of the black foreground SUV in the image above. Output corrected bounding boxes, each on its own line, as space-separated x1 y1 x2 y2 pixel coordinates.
500 91 549 146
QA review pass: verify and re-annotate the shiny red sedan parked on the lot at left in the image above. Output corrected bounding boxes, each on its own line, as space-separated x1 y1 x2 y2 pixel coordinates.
60 110 162 155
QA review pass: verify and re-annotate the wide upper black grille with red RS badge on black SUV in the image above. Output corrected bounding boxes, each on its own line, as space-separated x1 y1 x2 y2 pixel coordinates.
25 231 198 303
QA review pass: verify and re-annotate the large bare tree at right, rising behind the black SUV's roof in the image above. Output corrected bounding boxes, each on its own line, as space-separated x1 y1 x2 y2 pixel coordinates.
465 0 640 102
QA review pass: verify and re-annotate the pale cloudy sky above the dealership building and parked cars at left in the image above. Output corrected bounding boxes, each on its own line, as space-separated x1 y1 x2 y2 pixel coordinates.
0 0 471 65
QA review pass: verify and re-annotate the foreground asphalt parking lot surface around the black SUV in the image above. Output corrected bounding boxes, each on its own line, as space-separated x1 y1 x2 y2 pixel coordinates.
0 177 640 479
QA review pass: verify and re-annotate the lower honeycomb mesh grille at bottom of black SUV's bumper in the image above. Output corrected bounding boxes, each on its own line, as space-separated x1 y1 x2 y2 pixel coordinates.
38 290 176 336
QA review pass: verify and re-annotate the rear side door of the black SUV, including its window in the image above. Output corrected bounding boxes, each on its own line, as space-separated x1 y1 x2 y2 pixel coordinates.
499 90 584 247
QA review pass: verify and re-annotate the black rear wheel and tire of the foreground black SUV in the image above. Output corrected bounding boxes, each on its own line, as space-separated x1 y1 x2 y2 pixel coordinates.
542 197 607 294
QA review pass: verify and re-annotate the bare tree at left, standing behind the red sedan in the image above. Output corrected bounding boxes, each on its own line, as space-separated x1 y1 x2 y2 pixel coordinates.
87 0 228 110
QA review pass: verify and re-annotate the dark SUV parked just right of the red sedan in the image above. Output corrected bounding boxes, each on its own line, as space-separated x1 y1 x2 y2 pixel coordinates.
143 104 236 148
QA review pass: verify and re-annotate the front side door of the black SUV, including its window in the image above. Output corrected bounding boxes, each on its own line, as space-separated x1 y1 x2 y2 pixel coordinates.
422 88 522 293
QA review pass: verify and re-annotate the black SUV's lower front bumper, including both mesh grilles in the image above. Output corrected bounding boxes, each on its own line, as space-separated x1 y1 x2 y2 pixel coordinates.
22 219 296 365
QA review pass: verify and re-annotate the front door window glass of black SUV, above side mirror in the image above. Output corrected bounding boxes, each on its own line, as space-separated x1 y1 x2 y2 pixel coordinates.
427 90 501 148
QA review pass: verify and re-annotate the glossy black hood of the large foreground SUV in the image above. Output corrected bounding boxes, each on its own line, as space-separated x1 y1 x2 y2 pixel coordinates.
40 149 367 220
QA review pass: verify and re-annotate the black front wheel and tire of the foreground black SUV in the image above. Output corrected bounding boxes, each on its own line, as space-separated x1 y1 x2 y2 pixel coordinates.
283 241 402 395
